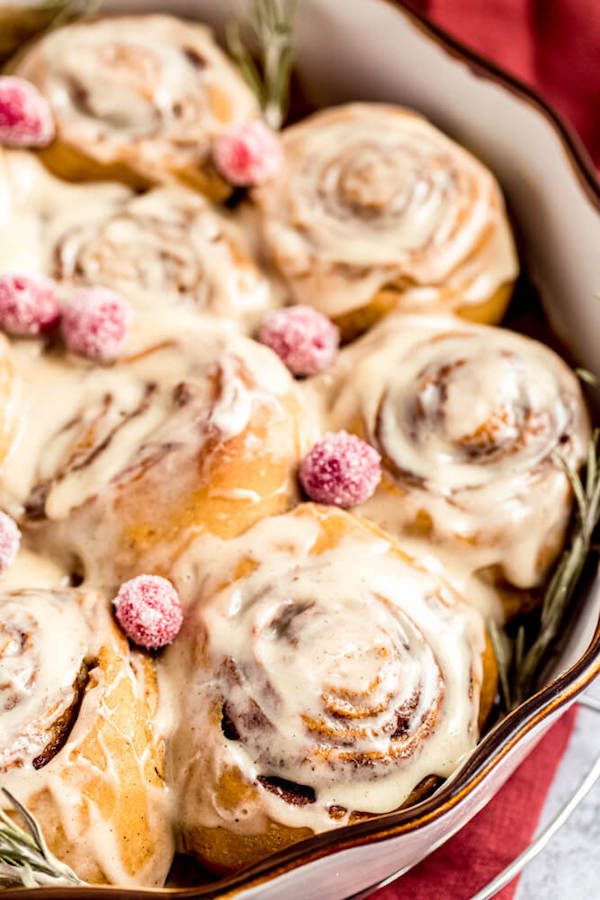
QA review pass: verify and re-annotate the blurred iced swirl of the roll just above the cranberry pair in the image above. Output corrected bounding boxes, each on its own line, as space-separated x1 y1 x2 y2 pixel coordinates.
54 187 273 332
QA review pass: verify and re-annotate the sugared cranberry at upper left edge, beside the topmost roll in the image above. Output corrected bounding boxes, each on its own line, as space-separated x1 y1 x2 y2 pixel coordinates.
0 75 54 147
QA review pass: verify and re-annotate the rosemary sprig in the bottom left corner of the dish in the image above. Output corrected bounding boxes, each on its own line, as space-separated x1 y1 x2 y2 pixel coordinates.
0 788 84 887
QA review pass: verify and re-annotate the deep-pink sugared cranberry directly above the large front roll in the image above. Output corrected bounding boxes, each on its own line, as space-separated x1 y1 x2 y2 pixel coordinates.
300 431 381 506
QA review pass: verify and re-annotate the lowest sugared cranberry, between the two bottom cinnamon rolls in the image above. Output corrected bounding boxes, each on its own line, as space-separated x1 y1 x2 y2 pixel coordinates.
113 575 183 650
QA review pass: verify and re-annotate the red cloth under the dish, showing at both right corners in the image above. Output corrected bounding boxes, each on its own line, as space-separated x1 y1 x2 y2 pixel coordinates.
369 0 600 900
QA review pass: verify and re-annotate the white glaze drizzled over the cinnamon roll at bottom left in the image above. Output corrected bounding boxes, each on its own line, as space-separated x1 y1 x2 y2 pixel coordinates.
0 589 173 887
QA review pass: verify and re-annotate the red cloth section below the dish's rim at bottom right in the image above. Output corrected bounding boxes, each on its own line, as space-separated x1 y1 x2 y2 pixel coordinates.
369 707 577 900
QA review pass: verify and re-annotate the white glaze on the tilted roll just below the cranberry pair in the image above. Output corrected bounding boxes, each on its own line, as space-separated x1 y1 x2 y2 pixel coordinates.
0 313 294 520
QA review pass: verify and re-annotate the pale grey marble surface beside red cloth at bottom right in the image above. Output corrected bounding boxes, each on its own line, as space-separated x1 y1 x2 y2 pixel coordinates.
515 678 600 900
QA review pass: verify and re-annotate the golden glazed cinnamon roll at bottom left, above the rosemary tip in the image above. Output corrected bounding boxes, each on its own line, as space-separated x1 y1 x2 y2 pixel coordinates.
0 589 174 886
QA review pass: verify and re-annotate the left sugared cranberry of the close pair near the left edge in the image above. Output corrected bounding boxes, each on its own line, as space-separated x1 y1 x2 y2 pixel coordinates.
0 273 60 334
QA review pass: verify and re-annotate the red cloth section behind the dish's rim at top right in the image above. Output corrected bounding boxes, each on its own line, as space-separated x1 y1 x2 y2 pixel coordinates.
406 0 600 166
